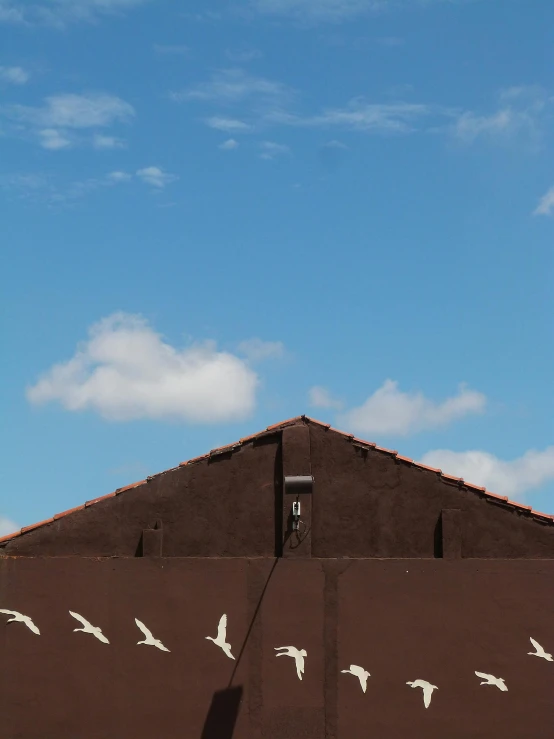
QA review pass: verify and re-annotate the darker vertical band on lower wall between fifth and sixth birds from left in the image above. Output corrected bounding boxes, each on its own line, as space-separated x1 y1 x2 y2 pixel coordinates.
323 561 339 739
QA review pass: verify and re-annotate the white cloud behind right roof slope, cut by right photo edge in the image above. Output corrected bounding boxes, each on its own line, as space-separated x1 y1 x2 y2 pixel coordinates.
421 446 554 499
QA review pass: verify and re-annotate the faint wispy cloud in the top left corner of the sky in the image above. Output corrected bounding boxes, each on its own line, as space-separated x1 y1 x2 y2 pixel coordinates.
0 0 150 28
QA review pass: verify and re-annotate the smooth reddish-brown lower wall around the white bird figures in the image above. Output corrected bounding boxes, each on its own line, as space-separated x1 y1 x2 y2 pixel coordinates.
0 557 554 739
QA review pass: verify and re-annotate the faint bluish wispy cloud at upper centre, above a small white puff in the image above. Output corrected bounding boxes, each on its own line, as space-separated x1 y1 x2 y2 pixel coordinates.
172 69 293 104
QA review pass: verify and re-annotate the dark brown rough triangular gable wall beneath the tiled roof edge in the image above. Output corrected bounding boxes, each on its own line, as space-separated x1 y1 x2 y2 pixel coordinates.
0 422 554 559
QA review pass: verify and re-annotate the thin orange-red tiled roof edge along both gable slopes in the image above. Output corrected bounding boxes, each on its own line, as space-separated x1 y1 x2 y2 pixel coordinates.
0 416 554 546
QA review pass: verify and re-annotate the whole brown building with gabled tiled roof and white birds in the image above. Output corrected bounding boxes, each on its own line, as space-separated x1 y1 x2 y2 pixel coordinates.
0 417 554 739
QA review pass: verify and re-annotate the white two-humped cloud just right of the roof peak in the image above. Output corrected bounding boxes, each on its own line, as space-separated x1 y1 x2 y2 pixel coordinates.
340 380 486 436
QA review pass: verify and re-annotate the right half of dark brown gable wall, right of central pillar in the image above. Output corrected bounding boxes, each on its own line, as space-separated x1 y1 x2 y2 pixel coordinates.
310 426 554 556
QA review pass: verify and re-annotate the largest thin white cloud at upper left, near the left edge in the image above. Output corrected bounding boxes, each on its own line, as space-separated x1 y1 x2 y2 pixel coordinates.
6 93 135 128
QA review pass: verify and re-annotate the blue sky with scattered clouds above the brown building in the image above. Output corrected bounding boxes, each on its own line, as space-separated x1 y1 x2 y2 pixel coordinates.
0 0 554 533
